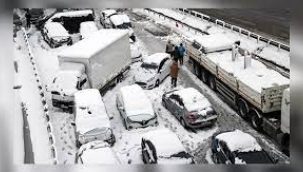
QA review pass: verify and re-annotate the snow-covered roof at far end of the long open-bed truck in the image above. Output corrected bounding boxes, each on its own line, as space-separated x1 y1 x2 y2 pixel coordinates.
194 34 235 53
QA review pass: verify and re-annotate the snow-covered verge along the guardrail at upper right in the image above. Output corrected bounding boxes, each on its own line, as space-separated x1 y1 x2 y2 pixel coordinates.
137 9 290 69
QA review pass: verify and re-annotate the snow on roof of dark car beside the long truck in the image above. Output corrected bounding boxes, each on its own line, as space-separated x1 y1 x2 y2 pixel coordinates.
172 87 211 111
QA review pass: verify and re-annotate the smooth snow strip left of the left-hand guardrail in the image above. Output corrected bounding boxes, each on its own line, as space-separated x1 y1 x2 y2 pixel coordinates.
14 31 53 164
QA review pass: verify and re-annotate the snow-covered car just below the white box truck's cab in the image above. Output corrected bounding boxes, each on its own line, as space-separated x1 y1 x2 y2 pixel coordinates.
74 89 116 147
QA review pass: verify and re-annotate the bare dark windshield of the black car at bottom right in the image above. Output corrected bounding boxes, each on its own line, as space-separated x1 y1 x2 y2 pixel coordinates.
235 150 273 164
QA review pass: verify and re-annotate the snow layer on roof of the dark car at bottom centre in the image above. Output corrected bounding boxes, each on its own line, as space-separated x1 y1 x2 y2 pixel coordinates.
142 128 186 157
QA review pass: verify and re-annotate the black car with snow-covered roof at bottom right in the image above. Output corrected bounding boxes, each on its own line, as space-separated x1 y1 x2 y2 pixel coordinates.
211 130 277 164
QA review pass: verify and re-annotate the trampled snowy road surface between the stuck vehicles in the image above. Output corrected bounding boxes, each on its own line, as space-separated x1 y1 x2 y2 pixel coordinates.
14 8 289 164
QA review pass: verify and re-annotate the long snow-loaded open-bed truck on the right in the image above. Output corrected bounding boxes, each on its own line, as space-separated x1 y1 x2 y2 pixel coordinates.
185 34 290 153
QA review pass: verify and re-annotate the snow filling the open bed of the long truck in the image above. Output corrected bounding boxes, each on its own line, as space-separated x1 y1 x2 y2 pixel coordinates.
207 51 290 93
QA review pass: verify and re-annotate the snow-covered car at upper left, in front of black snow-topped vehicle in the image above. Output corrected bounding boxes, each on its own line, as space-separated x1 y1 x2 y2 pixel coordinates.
42 22 72 48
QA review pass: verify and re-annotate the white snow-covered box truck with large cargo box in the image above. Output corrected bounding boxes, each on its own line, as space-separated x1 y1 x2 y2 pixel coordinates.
51 29 131 107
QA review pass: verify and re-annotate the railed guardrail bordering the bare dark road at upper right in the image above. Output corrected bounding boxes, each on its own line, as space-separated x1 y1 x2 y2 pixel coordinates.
177 8 290 51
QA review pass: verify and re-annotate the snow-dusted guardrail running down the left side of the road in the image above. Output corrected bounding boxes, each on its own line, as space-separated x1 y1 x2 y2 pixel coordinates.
22 27 58 164
